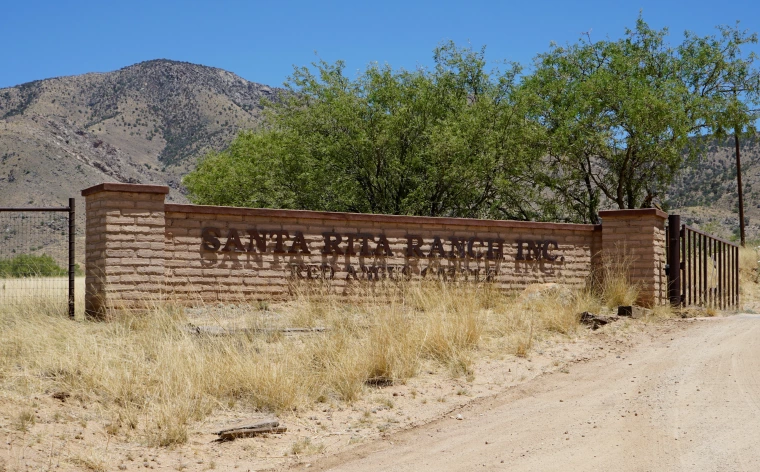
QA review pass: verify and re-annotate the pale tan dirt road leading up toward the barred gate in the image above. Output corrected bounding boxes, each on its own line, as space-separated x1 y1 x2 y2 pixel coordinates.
309 315 760 472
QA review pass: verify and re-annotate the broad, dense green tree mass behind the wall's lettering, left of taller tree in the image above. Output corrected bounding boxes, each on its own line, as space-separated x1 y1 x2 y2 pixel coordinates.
184 43 551 219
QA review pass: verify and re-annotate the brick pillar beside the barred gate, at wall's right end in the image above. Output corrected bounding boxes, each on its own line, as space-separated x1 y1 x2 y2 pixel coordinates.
599 208 668 306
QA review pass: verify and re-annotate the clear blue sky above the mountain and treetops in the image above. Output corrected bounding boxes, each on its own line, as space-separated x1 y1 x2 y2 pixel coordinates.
0 0 760 88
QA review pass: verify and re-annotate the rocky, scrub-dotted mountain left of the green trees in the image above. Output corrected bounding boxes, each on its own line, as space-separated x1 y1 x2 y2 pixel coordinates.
0 60 277 206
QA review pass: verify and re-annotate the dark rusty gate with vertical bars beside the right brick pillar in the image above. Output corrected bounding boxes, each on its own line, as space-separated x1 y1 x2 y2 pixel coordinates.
667 215 739 310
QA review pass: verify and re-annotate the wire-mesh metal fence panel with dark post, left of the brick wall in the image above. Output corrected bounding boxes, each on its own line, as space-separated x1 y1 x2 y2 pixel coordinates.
0 198 76 319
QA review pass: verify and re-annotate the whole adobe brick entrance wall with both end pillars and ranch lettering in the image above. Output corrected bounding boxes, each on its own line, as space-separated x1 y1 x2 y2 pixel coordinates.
82 184 664 316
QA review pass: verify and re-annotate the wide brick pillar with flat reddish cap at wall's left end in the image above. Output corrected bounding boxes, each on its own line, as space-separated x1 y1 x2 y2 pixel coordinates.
82 183 169 319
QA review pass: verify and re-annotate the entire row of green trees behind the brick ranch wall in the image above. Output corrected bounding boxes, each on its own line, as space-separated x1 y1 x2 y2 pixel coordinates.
184 18 760 222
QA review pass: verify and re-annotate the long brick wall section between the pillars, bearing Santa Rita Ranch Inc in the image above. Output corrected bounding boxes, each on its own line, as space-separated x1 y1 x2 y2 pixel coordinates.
165 204 601 302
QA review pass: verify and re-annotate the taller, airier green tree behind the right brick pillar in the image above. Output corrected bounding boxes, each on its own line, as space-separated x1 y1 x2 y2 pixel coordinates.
523 17 757 222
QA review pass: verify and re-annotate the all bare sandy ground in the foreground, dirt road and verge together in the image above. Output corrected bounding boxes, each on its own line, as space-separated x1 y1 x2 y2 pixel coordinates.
0 315 760 471
